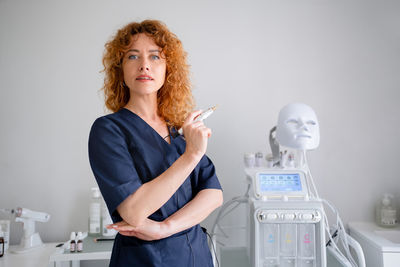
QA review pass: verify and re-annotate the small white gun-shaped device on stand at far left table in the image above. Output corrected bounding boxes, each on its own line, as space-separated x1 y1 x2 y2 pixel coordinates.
11 208 50 253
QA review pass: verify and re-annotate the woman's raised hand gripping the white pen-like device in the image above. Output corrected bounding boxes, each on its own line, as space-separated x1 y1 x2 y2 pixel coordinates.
182 110 211 160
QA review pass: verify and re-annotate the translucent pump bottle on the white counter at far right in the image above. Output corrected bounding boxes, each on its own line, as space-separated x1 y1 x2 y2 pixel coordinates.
376 193 397 227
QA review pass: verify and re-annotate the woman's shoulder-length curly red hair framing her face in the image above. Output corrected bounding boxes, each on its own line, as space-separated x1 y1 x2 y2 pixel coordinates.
102 20 194 128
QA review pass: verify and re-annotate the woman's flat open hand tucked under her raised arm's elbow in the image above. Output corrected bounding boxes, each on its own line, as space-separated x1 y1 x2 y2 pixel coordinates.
107 219 170 241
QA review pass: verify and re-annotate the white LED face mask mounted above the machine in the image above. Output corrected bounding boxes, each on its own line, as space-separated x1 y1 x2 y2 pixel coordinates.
276 103 319 150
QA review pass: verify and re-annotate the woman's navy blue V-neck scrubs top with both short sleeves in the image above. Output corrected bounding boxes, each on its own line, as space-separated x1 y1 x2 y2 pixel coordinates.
89 108 221 267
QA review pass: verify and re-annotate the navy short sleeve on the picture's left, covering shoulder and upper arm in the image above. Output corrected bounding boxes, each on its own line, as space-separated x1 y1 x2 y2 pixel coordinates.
89 117 142 219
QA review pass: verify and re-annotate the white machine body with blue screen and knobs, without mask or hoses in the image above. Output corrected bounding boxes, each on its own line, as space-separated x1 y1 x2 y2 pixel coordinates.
245 167 326 267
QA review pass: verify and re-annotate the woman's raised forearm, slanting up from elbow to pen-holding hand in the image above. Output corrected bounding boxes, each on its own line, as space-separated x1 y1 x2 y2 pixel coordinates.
117 153 200 226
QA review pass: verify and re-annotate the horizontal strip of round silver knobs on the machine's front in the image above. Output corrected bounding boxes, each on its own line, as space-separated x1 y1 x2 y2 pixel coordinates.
256 210 322 223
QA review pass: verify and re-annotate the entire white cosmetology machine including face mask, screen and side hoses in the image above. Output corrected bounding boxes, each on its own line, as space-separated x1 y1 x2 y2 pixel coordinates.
211 103 365 267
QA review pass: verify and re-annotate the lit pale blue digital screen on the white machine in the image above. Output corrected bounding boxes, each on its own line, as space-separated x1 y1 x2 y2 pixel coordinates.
258 173 301 192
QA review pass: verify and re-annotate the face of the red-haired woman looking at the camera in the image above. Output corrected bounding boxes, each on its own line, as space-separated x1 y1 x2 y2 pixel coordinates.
122 33 167 96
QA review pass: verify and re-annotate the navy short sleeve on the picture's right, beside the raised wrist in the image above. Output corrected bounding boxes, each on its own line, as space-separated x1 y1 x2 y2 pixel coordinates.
196 155 222 192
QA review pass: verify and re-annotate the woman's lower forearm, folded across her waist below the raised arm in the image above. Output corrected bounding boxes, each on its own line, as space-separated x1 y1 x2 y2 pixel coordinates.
164 189 223 235
